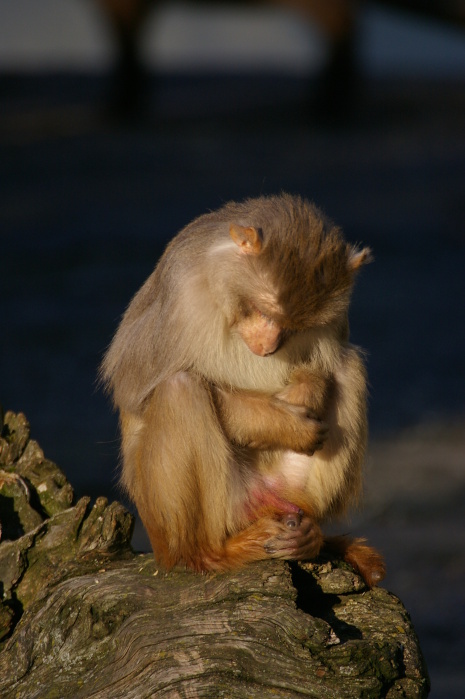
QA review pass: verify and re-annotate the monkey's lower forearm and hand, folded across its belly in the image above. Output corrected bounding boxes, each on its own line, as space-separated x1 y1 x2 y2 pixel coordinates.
212 387 327 453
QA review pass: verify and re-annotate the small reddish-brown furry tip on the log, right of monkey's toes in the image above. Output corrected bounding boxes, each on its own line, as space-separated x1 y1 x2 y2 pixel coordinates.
320 536 386 588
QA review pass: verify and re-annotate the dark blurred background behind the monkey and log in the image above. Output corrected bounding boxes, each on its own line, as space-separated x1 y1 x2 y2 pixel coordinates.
0 0 465 699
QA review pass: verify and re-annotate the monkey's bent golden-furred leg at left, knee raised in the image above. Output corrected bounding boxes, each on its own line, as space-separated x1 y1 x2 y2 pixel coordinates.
121 372 239 569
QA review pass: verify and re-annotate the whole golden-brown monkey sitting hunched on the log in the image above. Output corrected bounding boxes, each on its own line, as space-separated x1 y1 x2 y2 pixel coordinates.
102 194 384 586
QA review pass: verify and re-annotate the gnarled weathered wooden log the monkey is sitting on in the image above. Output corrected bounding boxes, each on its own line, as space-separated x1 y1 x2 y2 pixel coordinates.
0 413 429 699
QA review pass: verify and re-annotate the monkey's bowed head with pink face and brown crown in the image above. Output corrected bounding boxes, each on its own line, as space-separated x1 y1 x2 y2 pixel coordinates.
221 195 371 356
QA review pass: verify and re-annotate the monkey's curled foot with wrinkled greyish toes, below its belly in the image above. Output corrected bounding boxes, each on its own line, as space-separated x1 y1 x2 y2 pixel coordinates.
265 511 323 561
